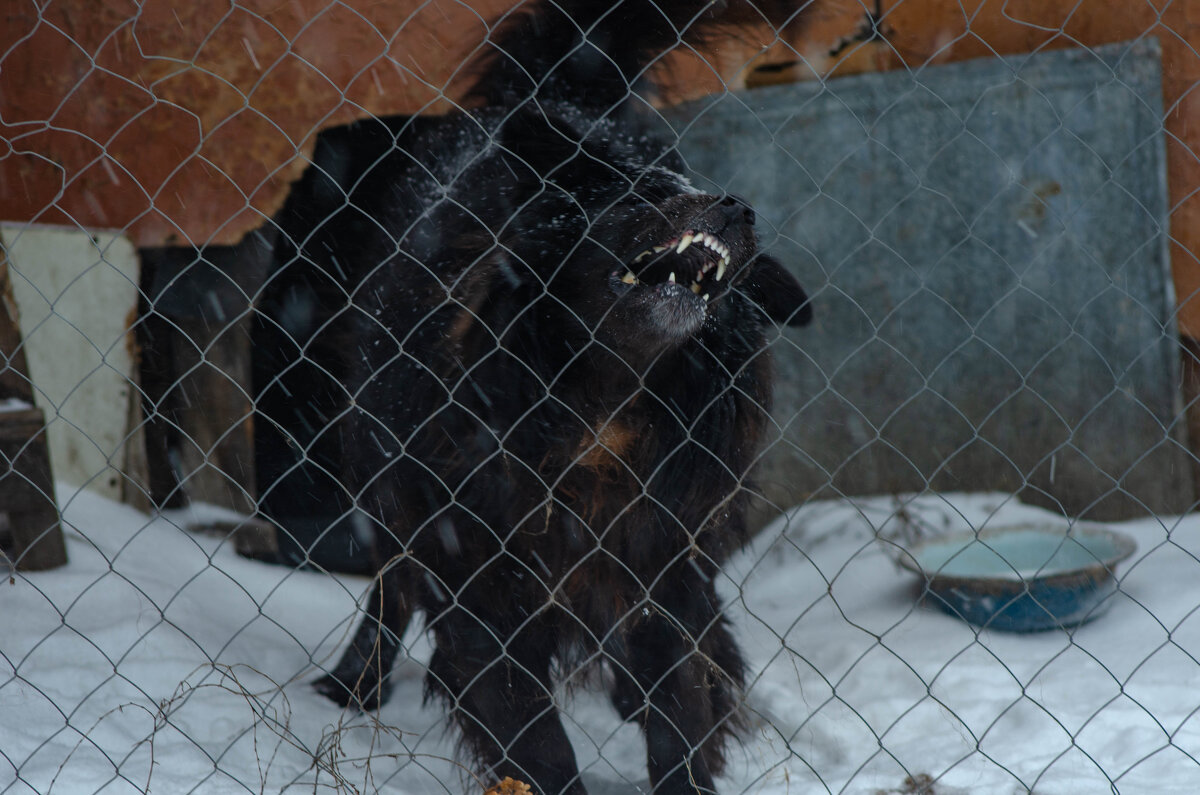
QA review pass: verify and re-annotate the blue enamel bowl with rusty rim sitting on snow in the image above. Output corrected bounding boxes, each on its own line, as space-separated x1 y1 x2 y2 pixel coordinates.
899 525 1138 632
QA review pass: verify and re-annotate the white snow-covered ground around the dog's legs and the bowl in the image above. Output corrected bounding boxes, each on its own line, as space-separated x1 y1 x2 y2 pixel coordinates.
0 486 1200 795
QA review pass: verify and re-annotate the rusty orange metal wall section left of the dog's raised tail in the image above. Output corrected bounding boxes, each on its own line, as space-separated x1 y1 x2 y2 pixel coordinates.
0 0 503 245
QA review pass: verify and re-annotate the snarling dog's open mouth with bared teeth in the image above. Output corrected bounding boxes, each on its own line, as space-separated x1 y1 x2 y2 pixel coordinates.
618 229 731 303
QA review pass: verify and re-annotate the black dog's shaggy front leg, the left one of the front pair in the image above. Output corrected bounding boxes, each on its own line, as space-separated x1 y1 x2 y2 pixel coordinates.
428 605 587 795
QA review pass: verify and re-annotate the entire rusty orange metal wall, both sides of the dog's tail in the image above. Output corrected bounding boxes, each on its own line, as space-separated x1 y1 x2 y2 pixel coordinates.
7 0 1200 336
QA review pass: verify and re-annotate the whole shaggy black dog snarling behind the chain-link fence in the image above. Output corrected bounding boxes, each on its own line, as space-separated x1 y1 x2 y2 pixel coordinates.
267 0 810 795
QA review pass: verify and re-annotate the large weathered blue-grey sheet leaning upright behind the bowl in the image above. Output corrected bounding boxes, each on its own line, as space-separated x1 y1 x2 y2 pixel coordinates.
671 40 1194 519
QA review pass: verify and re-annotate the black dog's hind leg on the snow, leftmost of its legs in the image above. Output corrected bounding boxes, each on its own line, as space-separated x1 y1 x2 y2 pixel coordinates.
313 561 413 710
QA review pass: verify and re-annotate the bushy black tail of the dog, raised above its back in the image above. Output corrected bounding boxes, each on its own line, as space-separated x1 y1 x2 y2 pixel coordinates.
469 0 815 109
